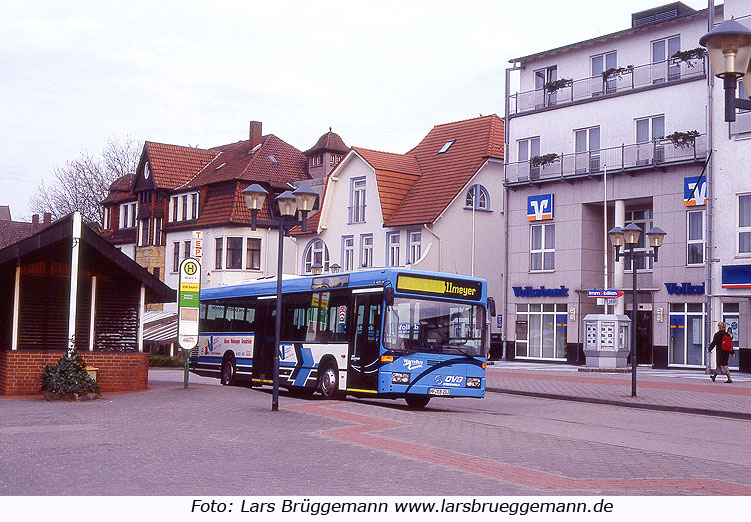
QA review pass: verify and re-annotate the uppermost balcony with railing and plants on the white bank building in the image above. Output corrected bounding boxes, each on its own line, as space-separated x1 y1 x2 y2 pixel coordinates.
509 56 708 116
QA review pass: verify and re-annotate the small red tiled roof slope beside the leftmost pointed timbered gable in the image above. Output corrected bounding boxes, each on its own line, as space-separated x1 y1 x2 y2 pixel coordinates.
144 141 218 190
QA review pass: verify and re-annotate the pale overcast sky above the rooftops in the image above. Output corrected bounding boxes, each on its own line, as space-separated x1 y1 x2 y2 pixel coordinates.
0 0 720 216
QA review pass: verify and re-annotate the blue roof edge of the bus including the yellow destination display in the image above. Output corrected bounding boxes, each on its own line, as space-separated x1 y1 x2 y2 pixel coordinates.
201 268 487 304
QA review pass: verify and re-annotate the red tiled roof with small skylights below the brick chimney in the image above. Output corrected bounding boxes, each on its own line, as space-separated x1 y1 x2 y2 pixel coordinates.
175 134 310 189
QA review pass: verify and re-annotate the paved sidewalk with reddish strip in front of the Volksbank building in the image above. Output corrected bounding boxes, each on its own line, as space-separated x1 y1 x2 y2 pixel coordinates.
486 361 751 420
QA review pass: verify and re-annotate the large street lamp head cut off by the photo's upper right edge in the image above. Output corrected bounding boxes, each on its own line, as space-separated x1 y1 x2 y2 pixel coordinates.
699 18 751 122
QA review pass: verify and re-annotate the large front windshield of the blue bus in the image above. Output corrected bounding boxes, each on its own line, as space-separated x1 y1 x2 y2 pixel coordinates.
383 297 485 357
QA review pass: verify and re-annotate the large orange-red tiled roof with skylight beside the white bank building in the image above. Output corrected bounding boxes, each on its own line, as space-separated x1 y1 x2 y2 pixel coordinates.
384 114 503 226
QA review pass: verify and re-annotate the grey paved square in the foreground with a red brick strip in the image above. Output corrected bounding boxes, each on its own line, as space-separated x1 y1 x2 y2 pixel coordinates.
0 367 751 495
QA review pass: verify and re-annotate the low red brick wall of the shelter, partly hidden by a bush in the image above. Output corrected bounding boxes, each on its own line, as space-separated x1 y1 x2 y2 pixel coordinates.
0 350 149 395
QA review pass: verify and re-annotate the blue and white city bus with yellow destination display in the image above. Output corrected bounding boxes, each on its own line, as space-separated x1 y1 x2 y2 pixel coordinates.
190 268 495 408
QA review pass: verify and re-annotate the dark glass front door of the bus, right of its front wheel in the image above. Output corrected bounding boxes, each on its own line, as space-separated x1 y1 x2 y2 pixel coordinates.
347 293 383 392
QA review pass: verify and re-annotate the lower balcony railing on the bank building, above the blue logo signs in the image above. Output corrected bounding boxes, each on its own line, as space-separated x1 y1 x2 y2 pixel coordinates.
506 134 707 187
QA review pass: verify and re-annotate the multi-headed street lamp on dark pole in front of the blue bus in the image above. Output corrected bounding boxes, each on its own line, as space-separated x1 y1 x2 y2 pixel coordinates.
243 183 318 411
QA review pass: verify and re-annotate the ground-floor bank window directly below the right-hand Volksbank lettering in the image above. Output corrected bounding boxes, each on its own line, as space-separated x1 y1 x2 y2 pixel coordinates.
668 303 705 366
